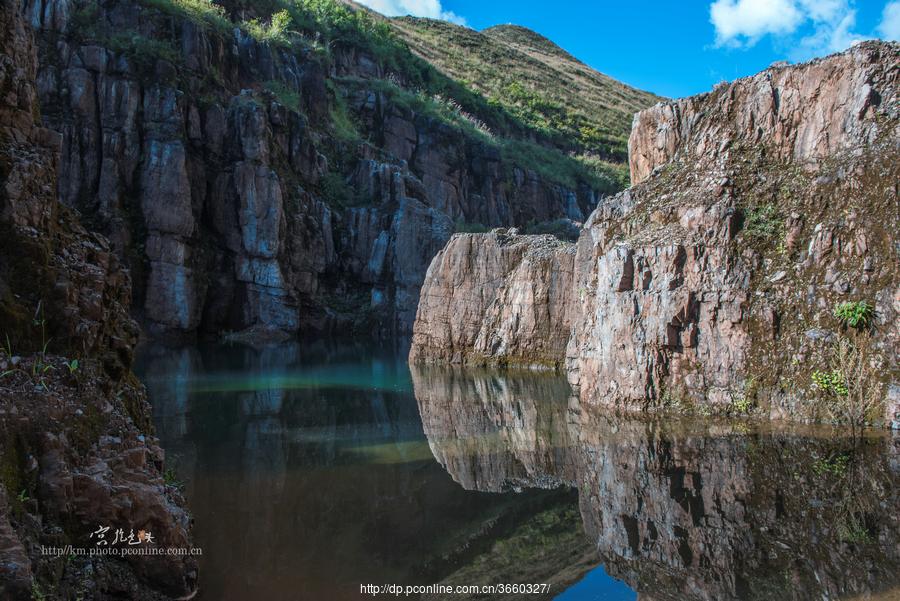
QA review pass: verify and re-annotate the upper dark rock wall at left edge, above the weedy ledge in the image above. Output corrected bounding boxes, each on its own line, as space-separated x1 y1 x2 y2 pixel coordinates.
0 0 137 374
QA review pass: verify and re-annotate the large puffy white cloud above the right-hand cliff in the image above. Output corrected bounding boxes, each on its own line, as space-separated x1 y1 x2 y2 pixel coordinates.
709 0 880 60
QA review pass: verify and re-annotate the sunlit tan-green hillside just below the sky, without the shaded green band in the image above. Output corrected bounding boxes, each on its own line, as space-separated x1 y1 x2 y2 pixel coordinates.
390 17 660 162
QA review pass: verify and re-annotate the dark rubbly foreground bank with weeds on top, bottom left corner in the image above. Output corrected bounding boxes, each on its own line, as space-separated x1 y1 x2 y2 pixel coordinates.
0 355 198 599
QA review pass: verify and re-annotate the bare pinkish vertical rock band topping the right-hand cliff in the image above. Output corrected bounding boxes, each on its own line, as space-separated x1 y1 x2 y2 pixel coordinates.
628 45 897 183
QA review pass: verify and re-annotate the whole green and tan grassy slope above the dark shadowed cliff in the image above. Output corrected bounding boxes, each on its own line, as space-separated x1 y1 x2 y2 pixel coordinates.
264 0 658 193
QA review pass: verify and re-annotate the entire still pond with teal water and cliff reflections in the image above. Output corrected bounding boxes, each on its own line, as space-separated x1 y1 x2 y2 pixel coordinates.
138 344 900 601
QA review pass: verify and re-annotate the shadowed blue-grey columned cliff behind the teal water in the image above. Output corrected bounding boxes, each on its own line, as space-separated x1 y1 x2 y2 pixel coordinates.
27 0 624 336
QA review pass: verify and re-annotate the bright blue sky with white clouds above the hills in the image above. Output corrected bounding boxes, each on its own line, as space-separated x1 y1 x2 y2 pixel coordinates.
357 0 900 97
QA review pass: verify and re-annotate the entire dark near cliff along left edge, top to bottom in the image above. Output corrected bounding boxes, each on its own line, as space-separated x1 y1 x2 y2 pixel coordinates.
0 1 196 599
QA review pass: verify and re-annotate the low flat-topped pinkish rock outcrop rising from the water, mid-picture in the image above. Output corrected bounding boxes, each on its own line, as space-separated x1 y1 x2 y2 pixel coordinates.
410 229 575 367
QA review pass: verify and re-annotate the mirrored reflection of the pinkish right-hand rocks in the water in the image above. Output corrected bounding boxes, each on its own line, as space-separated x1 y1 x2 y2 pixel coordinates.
412 367 900 600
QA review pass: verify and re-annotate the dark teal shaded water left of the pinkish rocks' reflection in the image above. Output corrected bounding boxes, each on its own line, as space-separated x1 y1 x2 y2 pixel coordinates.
139 344 612 601
